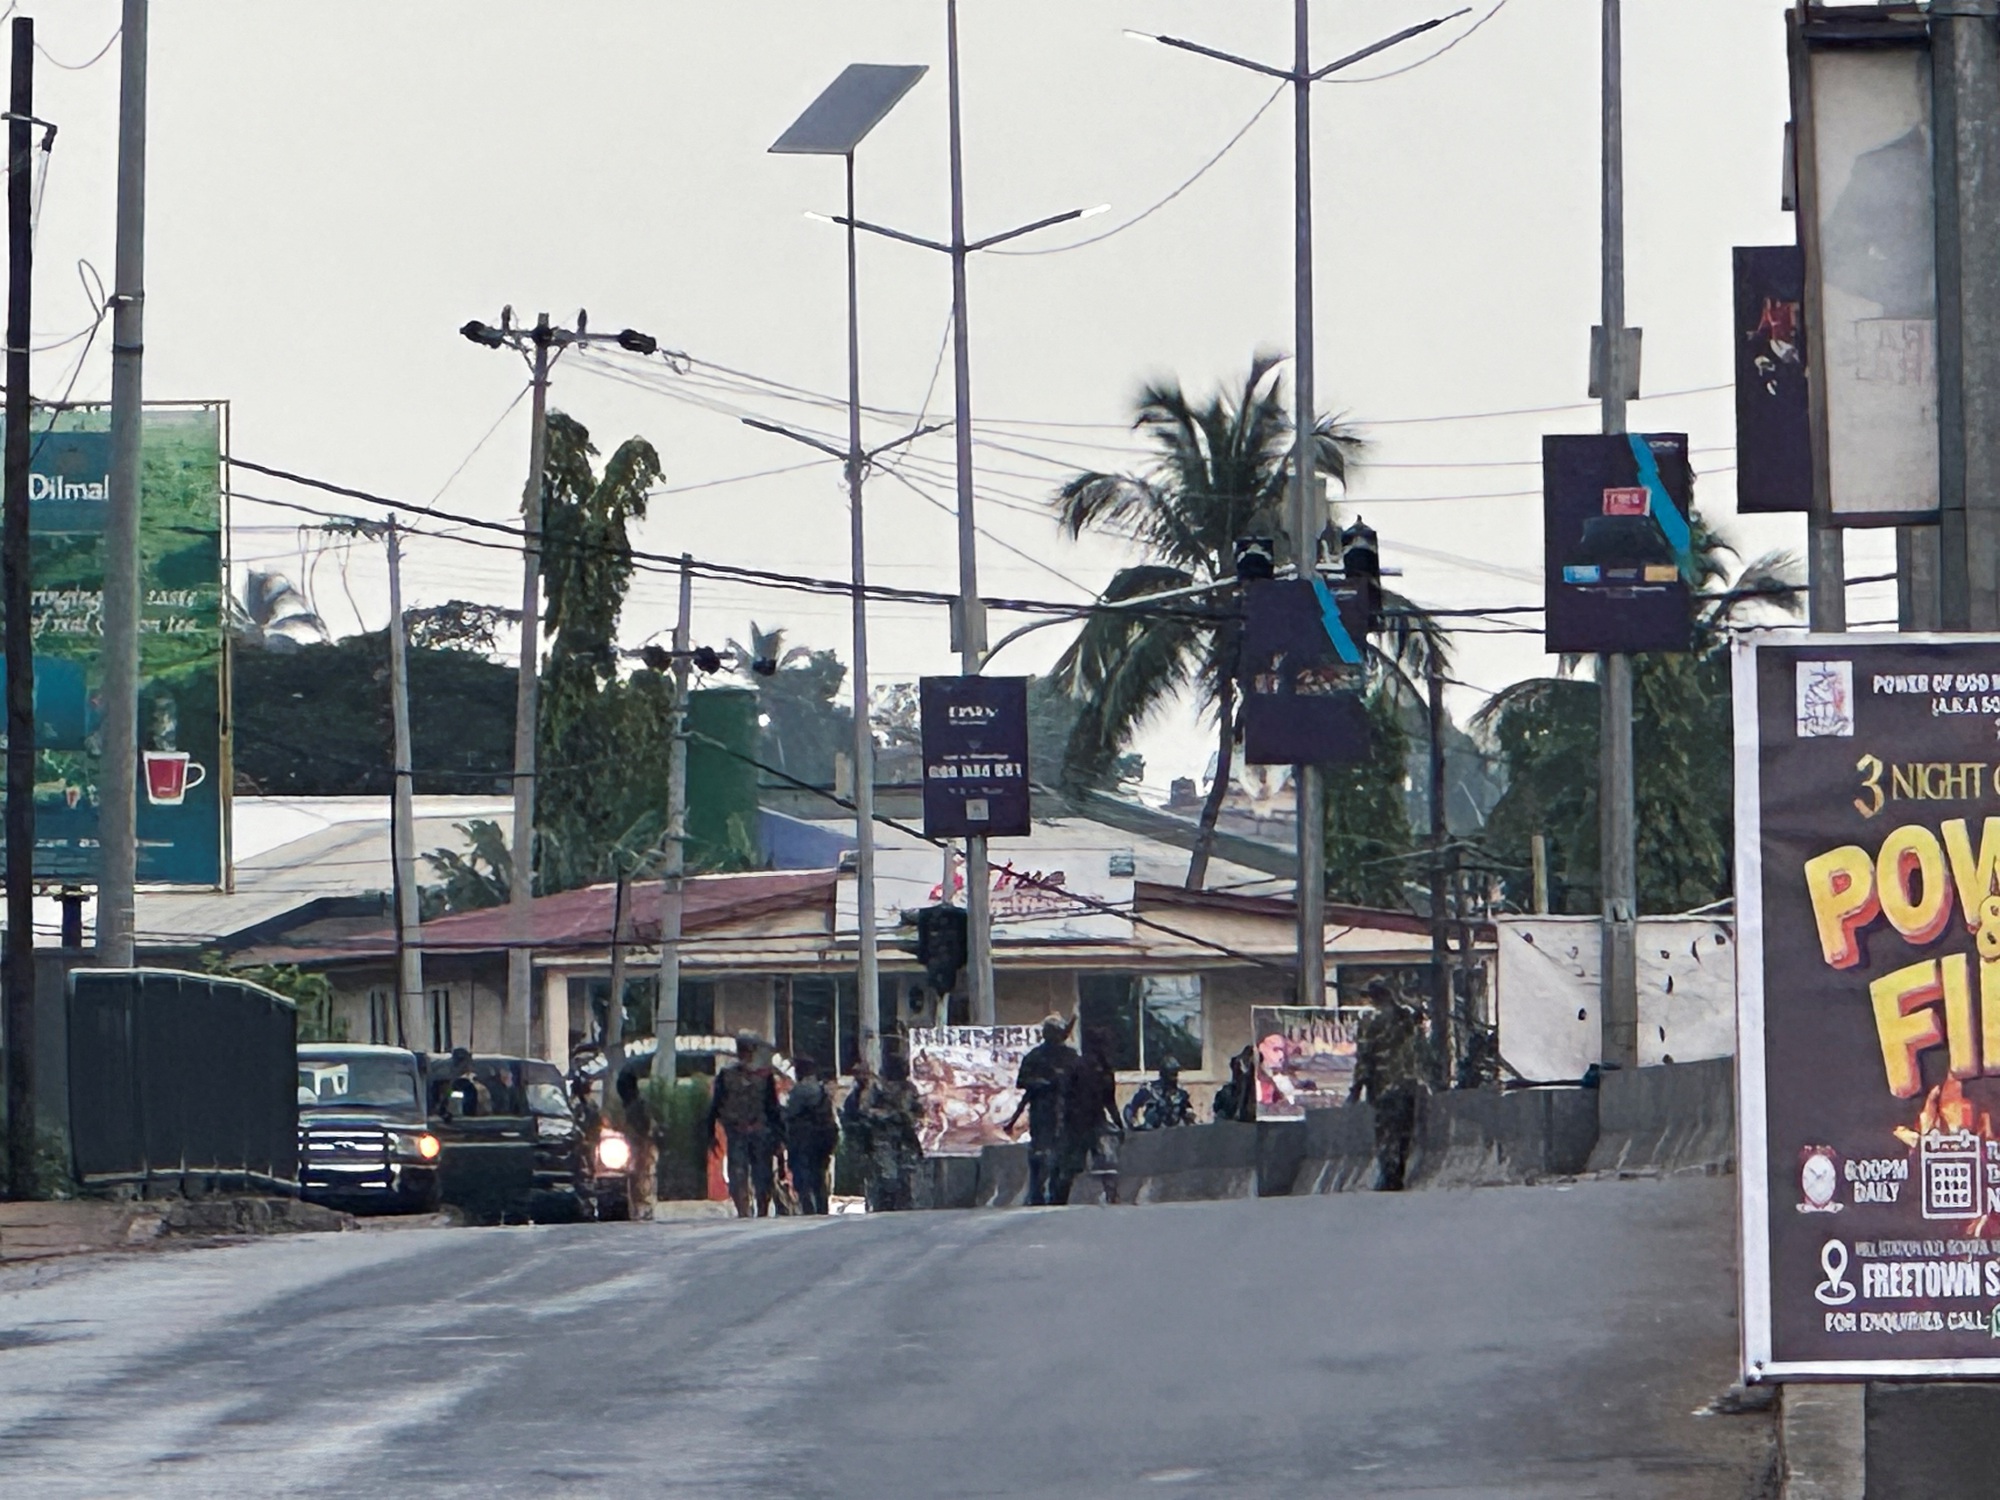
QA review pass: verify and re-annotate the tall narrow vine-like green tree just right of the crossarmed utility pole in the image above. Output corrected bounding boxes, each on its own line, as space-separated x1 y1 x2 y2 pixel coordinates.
534 412 674 894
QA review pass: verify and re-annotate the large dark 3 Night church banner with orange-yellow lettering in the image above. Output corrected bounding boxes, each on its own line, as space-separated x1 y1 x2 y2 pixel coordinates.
1736 636 2000 1380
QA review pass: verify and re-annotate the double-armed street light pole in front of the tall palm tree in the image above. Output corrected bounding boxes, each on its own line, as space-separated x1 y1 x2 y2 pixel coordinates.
1128 0 1466 1006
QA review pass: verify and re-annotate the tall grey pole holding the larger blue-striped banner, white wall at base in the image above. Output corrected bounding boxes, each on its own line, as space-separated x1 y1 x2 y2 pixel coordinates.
1598 0 1638 1068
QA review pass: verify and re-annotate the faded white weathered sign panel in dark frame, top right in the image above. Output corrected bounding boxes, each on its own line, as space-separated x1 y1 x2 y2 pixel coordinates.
1792 23 1938 526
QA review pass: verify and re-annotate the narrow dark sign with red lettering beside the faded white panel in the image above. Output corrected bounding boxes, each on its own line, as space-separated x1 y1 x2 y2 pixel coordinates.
1734 244 1812 514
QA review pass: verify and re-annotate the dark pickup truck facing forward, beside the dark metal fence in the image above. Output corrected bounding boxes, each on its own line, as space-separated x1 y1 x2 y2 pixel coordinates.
298 1044 442 1214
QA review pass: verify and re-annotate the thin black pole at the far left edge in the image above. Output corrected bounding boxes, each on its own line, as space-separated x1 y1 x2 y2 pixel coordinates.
0 16 34 1198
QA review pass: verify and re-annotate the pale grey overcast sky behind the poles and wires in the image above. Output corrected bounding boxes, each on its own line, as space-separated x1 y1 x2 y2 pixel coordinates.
16 0 1894 788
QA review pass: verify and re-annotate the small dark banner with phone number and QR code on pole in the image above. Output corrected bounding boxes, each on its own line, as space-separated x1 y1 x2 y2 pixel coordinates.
918 678 1030 838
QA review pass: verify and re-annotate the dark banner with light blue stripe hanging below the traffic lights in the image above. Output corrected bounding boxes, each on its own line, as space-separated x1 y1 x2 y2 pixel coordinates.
1242 578 1368 766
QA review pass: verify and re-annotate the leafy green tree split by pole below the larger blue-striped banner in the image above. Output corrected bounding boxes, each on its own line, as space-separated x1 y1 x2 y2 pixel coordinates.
1474 516 1800 912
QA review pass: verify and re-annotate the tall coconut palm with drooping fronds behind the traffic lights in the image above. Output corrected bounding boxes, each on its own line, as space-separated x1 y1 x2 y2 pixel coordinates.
1052 354 1362 890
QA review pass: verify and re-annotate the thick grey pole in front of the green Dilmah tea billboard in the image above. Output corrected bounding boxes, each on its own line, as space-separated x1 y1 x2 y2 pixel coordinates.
96 0 146 968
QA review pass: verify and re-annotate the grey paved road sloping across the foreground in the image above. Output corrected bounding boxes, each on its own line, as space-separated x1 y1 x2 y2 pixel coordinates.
0 1180 1772 1500
